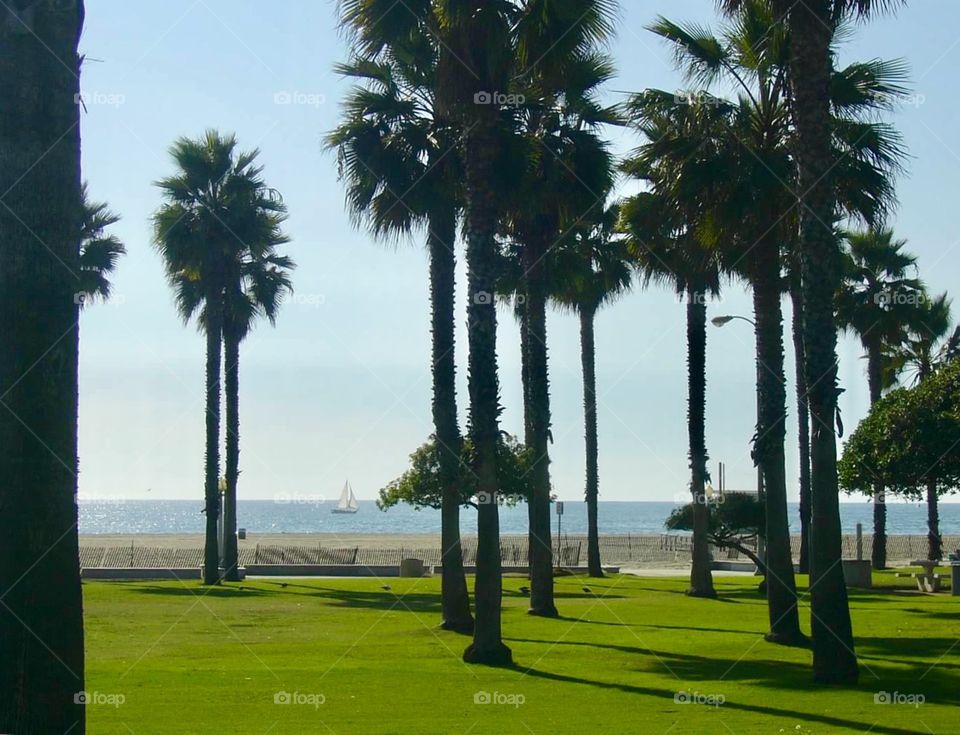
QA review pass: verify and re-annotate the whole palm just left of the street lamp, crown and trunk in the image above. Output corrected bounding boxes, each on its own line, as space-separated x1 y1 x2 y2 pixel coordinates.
622 190 720 597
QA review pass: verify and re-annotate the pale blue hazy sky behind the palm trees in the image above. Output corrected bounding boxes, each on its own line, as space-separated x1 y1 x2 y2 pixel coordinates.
73 0 960 500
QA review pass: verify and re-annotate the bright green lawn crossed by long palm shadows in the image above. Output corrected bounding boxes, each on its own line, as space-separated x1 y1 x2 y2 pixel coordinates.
84 575 960 735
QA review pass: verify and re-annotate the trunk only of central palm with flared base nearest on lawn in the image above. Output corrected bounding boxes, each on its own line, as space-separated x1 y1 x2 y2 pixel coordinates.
463 115 512 665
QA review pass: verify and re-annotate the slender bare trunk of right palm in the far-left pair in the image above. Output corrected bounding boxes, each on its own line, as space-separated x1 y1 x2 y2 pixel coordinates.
223 327 240 582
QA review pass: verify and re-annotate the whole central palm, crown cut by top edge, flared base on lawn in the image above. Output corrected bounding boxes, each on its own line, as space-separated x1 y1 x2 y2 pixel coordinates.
434 0 516 665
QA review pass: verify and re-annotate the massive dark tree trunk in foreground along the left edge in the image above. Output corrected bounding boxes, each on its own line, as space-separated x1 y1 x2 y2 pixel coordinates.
0 0 86 735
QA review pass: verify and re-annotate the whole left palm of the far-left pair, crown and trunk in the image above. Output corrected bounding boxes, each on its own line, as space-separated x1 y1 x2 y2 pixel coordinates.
153 130 285 584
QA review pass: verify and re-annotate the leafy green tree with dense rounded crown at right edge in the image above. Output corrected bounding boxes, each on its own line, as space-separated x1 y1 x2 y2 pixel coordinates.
839 364 960 559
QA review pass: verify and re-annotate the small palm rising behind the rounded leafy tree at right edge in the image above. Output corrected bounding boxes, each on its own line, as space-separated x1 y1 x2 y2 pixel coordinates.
874 294 960 559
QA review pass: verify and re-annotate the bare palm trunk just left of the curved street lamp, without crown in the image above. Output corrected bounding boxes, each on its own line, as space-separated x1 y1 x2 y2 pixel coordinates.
687 290 717 597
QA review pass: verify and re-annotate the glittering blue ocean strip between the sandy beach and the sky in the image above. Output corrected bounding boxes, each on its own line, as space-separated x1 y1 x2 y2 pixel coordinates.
80 497 960 534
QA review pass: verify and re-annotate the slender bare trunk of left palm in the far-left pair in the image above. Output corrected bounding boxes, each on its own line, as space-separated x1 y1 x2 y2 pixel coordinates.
203 287 223 584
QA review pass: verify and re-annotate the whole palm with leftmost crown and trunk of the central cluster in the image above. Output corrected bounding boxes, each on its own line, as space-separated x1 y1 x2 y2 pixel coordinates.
327 3 473 633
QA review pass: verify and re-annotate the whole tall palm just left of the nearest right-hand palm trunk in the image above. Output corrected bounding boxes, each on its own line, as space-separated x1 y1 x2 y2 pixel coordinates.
652 0 902 643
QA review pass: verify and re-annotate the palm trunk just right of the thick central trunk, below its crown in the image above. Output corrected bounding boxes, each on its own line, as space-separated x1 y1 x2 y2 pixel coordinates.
523 242 559 617
